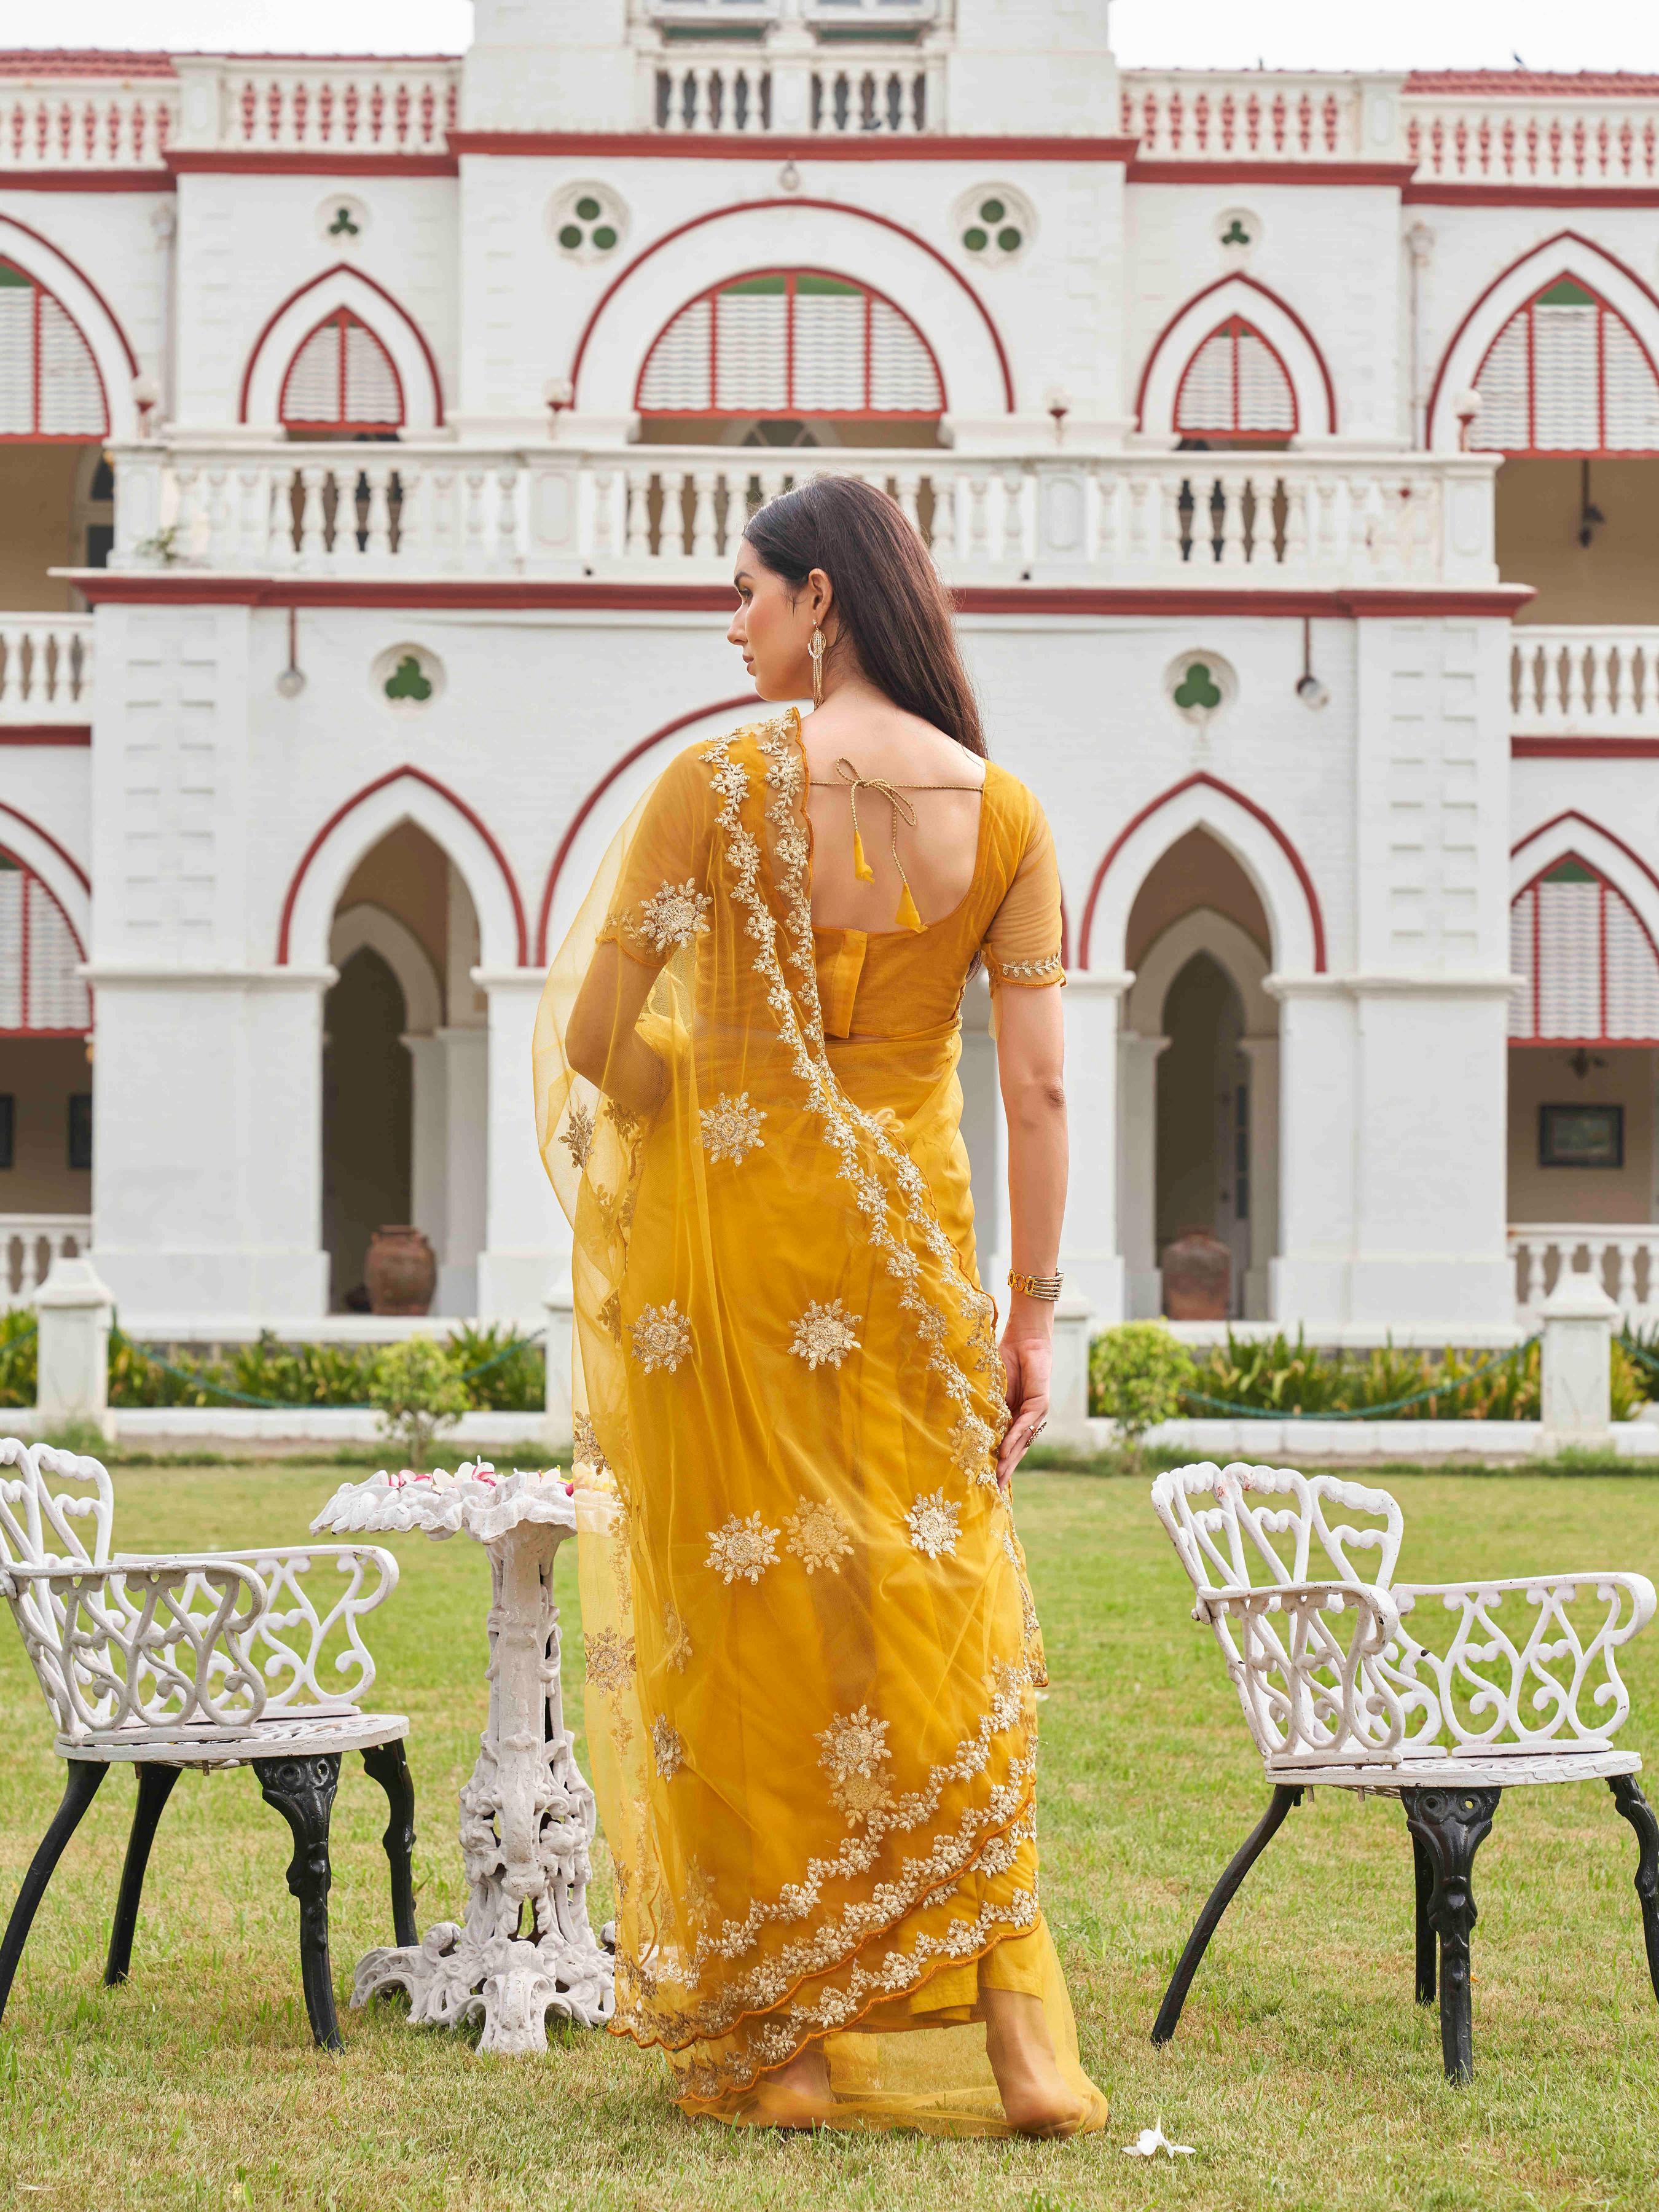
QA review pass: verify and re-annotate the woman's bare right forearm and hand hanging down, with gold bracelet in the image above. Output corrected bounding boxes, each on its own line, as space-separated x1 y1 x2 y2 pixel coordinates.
998 984 1066 1489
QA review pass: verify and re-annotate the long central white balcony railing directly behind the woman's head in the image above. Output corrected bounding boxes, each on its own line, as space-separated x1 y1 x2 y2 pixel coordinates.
115 445 1496 589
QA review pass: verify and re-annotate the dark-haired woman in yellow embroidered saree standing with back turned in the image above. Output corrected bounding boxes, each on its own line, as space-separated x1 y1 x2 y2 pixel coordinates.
535 478 1106 2135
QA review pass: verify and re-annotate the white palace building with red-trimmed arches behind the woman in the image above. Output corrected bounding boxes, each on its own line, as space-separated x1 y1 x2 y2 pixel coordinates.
0 0 1659 1343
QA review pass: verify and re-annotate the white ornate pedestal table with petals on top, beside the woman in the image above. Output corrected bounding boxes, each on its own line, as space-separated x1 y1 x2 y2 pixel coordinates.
312 1464 613 2053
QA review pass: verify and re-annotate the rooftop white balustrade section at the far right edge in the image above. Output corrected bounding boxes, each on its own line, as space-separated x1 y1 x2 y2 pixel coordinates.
1405 91 1659 186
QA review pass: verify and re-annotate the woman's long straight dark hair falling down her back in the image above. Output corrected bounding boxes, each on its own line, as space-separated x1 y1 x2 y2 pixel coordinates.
743 476 987 759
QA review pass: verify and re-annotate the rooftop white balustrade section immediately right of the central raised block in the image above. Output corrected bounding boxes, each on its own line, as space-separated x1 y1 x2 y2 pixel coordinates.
1120 69 1362 162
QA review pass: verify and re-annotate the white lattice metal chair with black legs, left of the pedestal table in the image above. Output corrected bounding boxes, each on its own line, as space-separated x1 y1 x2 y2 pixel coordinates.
0 1438 416 2050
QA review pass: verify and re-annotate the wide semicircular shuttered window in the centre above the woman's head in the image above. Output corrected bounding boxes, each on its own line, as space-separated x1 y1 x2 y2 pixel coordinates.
635 270 944 420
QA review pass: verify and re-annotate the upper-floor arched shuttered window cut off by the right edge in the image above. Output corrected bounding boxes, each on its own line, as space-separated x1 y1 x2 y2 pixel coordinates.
1469 276 1659 453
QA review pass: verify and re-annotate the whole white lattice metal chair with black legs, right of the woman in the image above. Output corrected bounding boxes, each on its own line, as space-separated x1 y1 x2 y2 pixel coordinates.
1153 1462 1659 2082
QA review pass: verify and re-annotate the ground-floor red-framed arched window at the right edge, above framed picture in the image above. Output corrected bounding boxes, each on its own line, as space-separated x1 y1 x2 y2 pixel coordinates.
1508 854 1659 1044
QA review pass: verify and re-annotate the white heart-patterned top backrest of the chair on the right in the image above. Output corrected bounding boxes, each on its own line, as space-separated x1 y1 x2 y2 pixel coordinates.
1153 1460 1405 1590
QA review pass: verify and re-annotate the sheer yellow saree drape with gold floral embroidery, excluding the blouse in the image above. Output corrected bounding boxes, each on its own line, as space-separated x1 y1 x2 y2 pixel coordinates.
535 712 1104 2135
